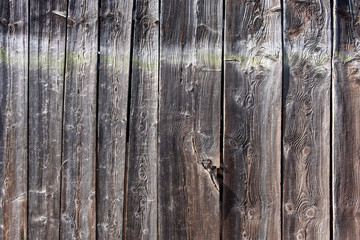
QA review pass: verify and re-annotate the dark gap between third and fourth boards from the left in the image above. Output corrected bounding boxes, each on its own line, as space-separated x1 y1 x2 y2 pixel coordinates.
95 0 101 239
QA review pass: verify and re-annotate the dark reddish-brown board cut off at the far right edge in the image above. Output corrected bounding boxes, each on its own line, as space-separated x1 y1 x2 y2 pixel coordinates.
332 0 360 240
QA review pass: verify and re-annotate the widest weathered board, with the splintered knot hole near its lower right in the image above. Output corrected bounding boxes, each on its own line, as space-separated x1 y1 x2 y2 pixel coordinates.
158 0 223 239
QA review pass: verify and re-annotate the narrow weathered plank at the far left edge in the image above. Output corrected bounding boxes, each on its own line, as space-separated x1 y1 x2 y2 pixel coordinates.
0 0 28 239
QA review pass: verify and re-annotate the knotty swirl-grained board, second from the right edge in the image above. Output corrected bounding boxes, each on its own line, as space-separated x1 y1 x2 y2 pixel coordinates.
282 0 331 239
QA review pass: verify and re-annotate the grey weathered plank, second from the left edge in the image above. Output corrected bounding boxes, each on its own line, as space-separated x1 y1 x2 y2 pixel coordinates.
28 0 67 239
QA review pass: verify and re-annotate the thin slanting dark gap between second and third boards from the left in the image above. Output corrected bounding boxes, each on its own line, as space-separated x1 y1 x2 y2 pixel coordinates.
59 0 70 239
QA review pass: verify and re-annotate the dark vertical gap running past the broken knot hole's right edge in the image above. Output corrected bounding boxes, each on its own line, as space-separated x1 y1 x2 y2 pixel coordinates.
217 0 226 240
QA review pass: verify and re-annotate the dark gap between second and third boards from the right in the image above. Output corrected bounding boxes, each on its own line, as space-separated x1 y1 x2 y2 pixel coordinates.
280 0 286 239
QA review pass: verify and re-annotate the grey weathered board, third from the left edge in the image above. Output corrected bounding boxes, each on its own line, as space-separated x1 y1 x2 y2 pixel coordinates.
60 0 98 239
